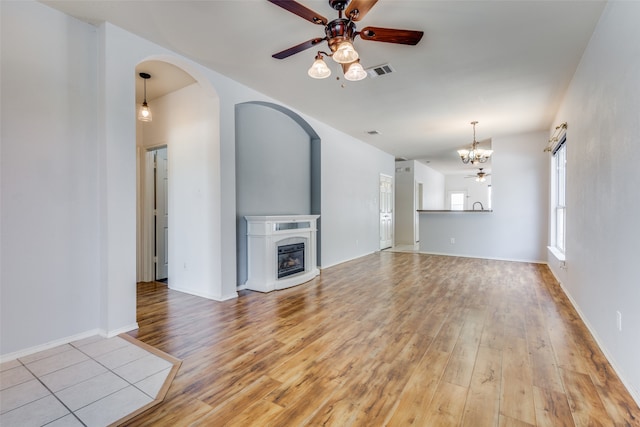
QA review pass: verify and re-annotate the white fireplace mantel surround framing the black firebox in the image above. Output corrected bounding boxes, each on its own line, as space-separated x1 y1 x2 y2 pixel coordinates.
245 215 320 292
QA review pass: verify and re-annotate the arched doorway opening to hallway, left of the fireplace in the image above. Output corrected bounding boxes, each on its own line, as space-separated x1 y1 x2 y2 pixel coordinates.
136 57 228 299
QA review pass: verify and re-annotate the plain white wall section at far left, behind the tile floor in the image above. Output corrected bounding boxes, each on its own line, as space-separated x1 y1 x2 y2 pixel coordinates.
0 2 101 354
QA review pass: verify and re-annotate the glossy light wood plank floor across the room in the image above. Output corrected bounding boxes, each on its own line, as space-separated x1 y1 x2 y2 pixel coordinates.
127 252 640 426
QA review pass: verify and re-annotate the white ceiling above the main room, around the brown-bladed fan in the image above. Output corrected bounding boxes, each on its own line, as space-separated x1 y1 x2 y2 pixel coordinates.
43 0 605 173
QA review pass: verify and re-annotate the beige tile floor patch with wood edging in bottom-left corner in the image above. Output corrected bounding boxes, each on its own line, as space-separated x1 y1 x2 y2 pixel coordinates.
0 336 180 427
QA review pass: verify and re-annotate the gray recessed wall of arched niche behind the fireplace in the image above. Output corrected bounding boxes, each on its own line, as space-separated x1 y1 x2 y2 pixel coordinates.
236 102 320 285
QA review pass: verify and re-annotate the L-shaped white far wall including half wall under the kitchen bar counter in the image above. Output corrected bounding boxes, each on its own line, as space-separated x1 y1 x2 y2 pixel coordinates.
420 132 549 262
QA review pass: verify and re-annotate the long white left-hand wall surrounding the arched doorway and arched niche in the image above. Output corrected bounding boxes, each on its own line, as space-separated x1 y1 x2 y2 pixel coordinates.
0 1 393 356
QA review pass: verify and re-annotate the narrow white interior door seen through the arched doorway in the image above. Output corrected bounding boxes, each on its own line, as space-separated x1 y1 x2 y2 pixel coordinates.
154 147 169 280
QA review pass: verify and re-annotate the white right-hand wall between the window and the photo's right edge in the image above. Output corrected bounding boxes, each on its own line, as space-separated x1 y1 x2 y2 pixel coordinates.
550 2 640 401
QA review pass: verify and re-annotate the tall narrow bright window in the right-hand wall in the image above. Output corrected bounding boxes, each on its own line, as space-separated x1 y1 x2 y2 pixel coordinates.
552 136 567 253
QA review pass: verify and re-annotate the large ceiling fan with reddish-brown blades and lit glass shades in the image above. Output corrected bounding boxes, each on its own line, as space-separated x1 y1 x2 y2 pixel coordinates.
268 0 424 81
